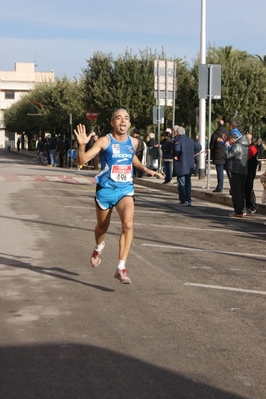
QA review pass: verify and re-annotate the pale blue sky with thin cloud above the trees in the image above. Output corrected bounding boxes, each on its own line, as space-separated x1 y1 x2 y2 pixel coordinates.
0 0 266 79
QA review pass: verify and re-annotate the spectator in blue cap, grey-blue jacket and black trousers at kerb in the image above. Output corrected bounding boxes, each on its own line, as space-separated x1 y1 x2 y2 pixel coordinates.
224 132 249 217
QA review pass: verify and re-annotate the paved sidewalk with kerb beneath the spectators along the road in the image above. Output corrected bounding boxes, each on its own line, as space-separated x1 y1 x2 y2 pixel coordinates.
6 149 266 214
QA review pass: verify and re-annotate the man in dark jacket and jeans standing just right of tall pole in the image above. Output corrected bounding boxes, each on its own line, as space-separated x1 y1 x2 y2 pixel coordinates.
210 119 231 193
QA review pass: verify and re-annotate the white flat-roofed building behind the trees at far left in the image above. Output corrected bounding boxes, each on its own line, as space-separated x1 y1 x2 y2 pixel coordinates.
0 62 54 148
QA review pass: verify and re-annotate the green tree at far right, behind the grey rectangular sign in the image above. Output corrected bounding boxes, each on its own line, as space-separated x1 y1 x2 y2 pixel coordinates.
193 46 266 131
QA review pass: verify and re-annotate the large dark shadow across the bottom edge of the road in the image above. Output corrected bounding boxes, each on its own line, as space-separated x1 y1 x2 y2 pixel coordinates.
0 343 243 399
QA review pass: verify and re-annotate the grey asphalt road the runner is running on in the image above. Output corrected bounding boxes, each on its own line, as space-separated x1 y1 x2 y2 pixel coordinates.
0 151 266 399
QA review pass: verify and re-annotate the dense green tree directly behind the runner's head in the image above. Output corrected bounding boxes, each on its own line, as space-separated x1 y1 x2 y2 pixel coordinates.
83 50 166 132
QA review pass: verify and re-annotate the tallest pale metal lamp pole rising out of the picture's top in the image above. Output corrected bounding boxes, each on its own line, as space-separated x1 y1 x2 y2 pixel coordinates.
199 0 206 179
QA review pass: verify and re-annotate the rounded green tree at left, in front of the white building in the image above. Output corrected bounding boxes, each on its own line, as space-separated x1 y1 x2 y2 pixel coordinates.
4 78 87 144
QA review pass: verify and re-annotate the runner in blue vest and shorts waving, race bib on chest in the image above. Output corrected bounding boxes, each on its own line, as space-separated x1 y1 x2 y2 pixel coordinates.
74 108 164 284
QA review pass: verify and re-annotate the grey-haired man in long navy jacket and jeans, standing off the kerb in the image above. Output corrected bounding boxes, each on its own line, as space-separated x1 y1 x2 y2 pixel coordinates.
173 126 201 206
